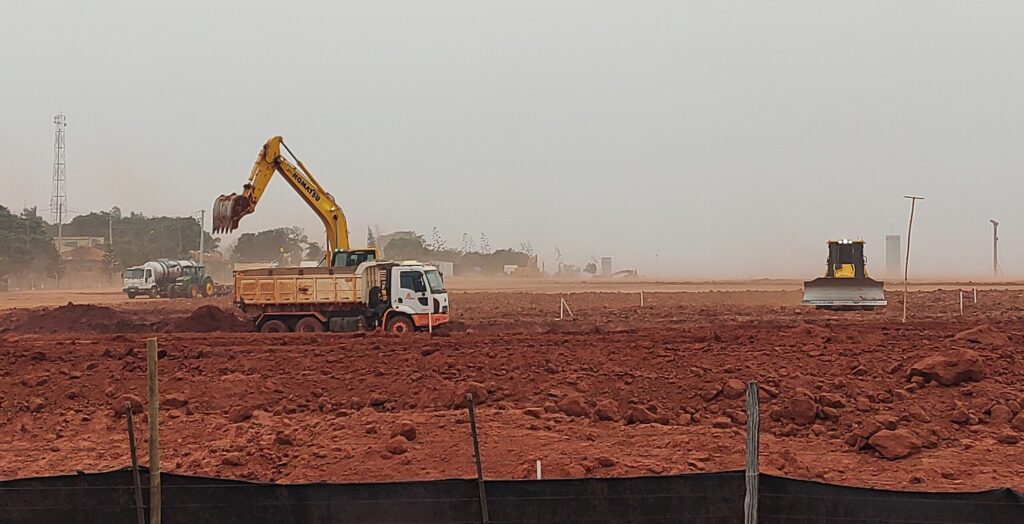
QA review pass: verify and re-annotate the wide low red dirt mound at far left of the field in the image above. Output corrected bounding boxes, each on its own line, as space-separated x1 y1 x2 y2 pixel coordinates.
10 302 151 335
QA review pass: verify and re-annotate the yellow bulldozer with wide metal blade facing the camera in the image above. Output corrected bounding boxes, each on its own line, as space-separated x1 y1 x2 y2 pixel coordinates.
801 239 886 310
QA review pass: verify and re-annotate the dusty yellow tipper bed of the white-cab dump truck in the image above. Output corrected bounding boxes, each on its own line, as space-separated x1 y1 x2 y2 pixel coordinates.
234 267 380 305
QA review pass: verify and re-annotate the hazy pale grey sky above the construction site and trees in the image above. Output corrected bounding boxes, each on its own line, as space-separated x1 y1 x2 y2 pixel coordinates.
0 0 1024 277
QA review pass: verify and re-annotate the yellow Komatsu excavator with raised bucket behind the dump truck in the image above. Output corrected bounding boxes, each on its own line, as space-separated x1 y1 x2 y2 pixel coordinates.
213 136 379 267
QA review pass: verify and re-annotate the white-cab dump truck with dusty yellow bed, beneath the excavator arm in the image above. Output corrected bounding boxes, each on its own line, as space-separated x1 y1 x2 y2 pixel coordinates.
234 260 449 335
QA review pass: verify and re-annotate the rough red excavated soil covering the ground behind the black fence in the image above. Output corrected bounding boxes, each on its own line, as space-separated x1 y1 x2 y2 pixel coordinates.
0 291 1024 490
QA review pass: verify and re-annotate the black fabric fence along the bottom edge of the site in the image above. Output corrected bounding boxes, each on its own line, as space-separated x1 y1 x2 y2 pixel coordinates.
0 470 1024 524
